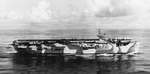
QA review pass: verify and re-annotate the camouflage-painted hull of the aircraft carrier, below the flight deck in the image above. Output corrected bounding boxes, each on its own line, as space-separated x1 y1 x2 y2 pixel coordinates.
14 43 136 57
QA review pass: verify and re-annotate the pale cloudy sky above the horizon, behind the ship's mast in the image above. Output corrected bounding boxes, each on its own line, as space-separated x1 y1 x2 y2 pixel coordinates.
0 0 150 30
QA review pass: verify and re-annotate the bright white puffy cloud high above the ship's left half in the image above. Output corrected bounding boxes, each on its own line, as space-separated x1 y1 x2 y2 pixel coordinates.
30 0 52 22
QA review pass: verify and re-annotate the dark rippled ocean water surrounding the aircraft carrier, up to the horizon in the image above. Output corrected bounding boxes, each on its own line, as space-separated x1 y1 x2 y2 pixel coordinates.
0 29 150 74
